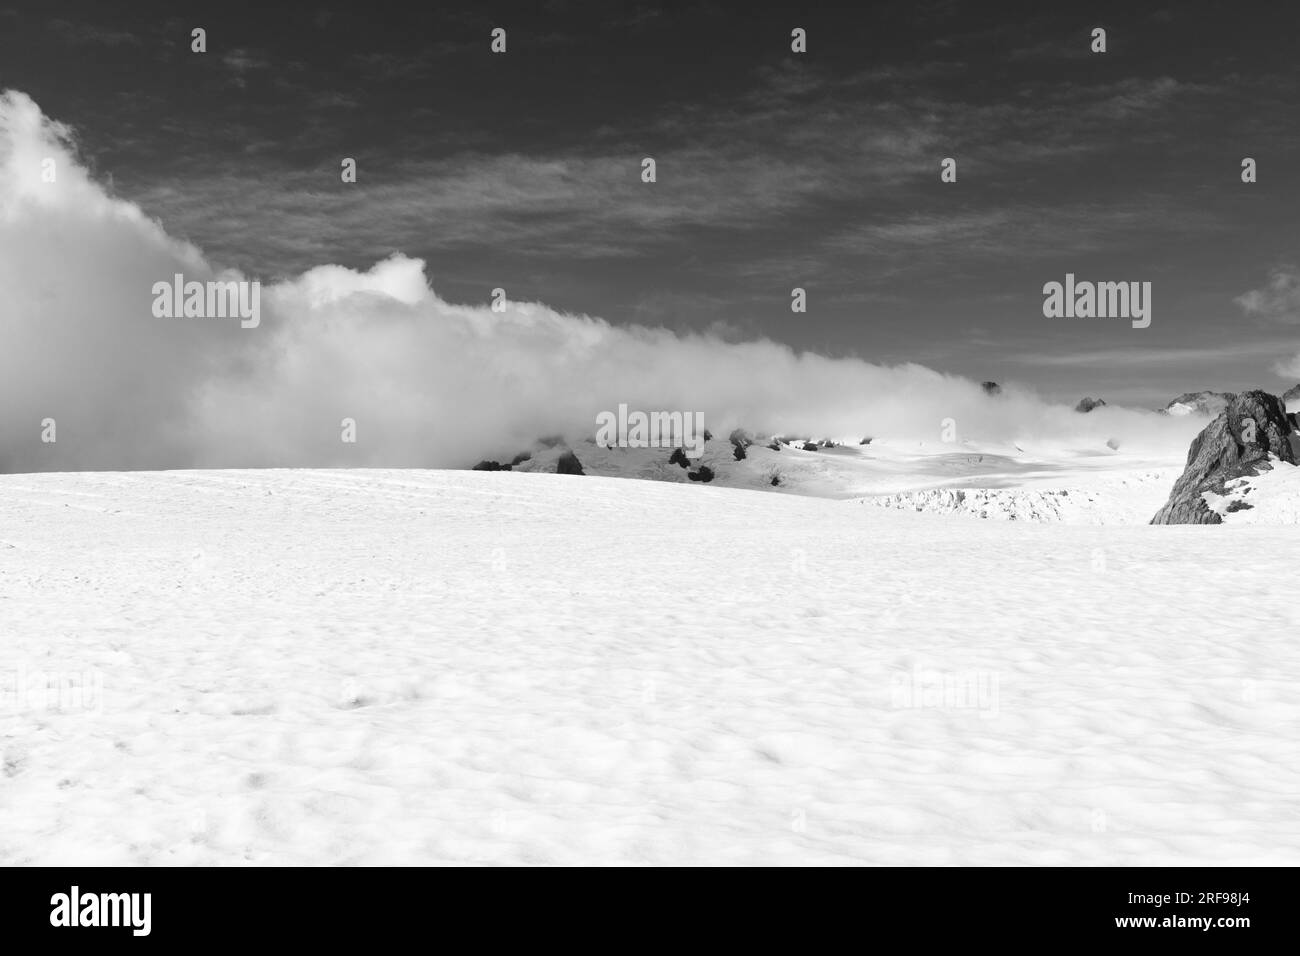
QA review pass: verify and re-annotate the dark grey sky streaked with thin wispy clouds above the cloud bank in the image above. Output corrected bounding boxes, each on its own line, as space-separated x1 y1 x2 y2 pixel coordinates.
0 0 1300 405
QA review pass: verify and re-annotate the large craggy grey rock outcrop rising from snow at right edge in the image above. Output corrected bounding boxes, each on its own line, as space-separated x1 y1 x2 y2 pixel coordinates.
1151 390 1296 524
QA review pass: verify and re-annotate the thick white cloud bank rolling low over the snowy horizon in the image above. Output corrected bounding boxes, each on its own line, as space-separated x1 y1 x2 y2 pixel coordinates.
0 91 1197 472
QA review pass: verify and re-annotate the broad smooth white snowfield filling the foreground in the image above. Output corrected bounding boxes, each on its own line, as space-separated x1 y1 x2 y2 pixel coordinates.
0 470 1300 865
